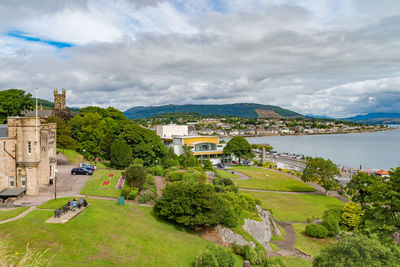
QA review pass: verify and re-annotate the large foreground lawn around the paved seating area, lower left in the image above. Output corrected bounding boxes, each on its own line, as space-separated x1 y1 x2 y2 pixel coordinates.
0 199 243 266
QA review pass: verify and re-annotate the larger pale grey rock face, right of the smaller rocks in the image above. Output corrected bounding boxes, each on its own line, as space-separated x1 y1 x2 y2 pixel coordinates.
243 206 282 250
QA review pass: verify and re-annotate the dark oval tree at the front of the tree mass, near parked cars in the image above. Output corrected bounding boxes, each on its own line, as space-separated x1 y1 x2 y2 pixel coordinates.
110 139 132 170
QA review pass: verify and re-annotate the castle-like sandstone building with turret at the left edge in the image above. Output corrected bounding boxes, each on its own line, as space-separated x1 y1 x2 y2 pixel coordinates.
0 117 57 198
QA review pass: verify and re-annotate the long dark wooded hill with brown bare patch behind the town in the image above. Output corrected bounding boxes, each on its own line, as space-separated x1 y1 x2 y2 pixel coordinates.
124 103 302 119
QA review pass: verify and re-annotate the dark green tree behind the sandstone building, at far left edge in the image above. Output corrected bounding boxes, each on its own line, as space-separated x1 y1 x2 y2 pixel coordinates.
0 89 34 124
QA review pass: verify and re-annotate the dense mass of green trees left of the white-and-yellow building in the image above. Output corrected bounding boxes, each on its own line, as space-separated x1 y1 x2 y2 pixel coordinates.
48 106 168 168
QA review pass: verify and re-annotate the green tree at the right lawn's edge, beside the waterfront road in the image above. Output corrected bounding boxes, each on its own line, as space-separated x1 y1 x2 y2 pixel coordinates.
301 158 340 195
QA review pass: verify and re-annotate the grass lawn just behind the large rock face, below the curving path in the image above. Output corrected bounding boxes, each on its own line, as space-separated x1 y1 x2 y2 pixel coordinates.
245 191 344 221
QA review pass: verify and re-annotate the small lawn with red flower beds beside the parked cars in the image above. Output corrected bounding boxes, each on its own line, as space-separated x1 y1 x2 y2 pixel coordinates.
81 169 122 197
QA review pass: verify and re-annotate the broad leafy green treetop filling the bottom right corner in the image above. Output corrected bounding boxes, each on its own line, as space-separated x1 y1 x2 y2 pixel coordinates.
313 233 400 267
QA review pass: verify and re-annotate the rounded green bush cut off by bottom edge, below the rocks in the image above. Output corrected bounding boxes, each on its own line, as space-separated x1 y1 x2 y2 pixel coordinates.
195 245 235 267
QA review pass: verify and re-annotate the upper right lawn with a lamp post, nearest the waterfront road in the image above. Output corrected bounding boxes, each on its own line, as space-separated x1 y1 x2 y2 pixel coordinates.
234 166 315 192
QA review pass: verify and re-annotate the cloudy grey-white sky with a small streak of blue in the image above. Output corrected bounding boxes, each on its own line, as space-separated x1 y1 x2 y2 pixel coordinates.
0 0 400 117
